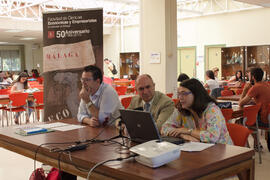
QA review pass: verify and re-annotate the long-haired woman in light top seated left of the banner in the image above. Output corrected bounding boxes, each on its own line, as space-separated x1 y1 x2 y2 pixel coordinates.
10 72 33 124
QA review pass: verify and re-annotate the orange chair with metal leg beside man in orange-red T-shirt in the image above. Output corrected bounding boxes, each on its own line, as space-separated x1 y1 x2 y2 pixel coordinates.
243 104 262 164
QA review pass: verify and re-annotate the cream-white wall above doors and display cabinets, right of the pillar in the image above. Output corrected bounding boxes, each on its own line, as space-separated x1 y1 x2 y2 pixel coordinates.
178 8 270 80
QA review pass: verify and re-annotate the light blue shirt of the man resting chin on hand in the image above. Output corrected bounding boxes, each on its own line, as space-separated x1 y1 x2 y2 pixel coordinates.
77 83 122 124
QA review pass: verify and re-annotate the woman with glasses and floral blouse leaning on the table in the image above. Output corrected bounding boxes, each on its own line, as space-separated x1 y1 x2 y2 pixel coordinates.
161 79 233 144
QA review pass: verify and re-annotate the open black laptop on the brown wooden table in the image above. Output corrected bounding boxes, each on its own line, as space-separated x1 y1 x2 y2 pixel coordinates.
120 109 185 144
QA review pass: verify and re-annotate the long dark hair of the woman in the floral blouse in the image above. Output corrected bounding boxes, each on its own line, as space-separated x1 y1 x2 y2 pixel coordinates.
180 78 217 117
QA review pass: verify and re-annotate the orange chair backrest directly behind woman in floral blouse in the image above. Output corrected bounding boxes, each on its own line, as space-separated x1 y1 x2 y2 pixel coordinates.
226 123 251 147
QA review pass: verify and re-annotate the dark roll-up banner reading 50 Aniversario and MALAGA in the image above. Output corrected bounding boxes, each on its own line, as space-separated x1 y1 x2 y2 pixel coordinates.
43 9 103 121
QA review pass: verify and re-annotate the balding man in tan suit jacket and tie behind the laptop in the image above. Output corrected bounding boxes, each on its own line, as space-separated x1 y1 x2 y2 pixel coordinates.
125 74 174 131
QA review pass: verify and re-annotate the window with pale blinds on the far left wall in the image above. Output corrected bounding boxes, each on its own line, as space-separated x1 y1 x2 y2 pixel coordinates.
0 50 21 71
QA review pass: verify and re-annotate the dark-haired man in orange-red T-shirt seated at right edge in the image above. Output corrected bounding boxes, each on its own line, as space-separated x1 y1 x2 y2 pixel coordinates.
239 68 270 150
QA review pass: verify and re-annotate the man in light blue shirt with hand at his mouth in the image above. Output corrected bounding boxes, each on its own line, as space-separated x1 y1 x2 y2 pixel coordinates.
77 65 122 127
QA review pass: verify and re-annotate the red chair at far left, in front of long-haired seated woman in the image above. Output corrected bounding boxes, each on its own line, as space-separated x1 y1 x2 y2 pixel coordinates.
4 93 28 126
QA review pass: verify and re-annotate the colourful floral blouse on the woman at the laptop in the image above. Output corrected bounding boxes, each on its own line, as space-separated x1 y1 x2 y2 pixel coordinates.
161 103 233 144
